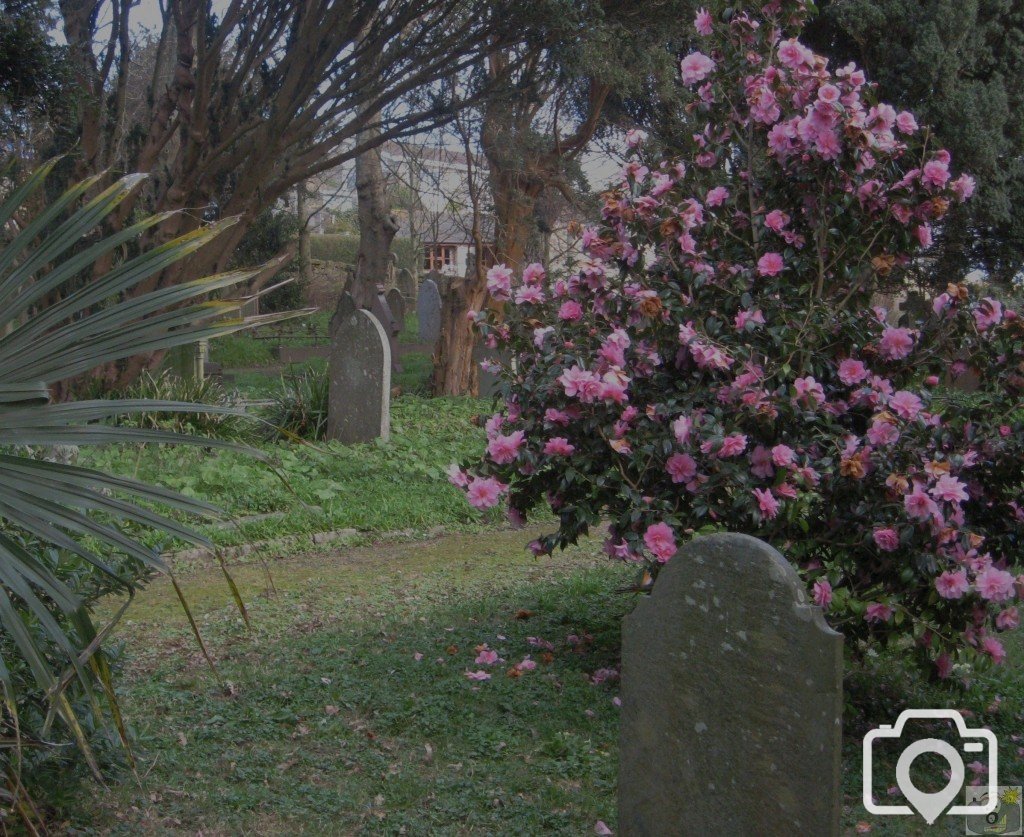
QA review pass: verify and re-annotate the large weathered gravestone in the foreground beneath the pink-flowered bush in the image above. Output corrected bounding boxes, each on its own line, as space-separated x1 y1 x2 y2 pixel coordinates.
618 534 843 837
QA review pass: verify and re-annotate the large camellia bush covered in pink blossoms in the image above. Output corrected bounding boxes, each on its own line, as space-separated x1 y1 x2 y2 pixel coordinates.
451 0 1024 677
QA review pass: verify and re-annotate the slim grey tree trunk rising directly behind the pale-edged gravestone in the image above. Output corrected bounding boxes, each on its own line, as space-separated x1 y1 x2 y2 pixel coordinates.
351 115 398 308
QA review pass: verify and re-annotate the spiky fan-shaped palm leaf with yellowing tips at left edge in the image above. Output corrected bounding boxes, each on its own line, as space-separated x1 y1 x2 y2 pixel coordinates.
0 163 303 782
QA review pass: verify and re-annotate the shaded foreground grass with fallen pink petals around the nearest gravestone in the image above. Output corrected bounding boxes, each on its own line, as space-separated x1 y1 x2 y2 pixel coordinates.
44 530 1024 835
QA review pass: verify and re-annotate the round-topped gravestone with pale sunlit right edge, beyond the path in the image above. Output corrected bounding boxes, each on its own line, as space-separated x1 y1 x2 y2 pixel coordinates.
327 294 391 445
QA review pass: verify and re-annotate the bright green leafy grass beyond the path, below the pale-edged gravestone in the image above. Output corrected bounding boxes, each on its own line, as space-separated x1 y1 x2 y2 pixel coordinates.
81 395 500 548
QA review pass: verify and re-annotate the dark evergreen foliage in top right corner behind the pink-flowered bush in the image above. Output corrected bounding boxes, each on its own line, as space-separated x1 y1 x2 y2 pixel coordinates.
804 0 1024 286
